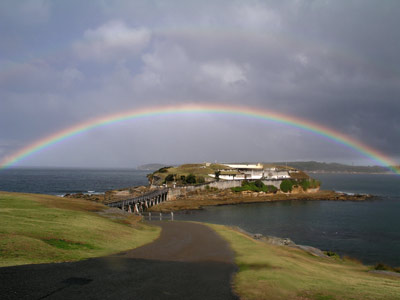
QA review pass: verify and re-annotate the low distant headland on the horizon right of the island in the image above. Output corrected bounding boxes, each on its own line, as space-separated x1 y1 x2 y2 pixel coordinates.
268 161 390 173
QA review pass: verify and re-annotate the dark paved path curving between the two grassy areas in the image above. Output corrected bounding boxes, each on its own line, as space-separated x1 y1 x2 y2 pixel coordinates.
0 222 237 299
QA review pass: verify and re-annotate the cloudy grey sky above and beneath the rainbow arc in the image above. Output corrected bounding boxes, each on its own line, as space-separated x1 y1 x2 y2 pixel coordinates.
0 0 400 168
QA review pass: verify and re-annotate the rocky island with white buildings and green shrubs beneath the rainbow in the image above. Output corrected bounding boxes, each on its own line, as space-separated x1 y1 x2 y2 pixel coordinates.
66 163 371 212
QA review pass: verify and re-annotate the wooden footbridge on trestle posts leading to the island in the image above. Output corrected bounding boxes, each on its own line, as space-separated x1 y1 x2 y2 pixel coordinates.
106 188 169 214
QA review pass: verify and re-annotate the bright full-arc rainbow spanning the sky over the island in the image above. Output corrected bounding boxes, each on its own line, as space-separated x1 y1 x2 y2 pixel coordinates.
0 104 400 174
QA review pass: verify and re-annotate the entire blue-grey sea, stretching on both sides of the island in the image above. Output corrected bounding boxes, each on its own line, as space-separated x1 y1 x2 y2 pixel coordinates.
0 169 400 266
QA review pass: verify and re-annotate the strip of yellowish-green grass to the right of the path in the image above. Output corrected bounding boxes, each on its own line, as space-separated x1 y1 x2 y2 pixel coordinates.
210 225 400 300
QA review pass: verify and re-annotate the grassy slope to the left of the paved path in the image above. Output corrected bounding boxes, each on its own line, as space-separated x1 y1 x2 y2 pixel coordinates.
0 192 160 266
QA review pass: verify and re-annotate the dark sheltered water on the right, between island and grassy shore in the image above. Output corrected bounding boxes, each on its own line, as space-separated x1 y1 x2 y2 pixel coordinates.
175 174 400 266
